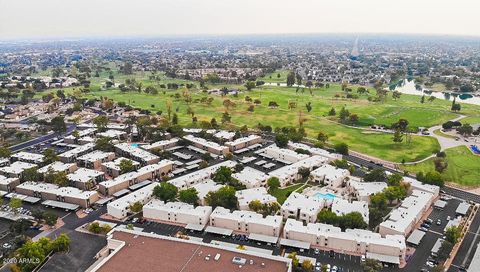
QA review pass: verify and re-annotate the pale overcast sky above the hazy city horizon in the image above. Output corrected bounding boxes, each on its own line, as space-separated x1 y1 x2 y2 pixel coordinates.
0 0 480 39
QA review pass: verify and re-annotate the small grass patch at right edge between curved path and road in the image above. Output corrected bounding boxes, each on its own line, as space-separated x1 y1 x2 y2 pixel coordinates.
402 146 480 186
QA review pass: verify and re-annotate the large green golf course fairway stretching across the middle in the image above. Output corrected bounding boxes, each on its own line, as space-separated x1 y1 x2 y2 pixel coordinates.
36 76 480 162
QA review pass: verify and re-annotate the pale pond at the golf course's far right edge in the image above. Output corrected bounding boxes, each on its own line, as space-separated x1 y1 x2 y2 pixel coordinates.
395 79 480 105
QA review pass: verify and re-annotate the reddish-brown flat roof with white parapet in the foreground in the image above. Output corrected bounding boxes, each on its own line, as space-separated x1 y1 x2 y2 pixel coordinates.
97 230 291 272
